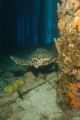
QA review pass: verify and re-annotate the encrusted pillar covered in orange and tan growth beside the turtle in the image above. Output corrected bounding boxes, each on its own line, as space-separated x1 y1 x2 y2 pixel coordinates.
55 0 80 109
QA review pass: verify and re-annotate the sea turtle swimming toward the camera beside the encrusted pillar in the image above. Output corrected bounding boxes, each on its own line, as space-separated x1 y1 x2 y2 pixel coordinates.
10 48 55 68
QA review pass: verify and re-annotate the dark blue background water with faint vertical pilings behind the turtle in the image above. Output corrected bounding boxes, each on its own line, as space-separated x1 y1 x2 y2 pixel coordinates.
0 0 58 53
